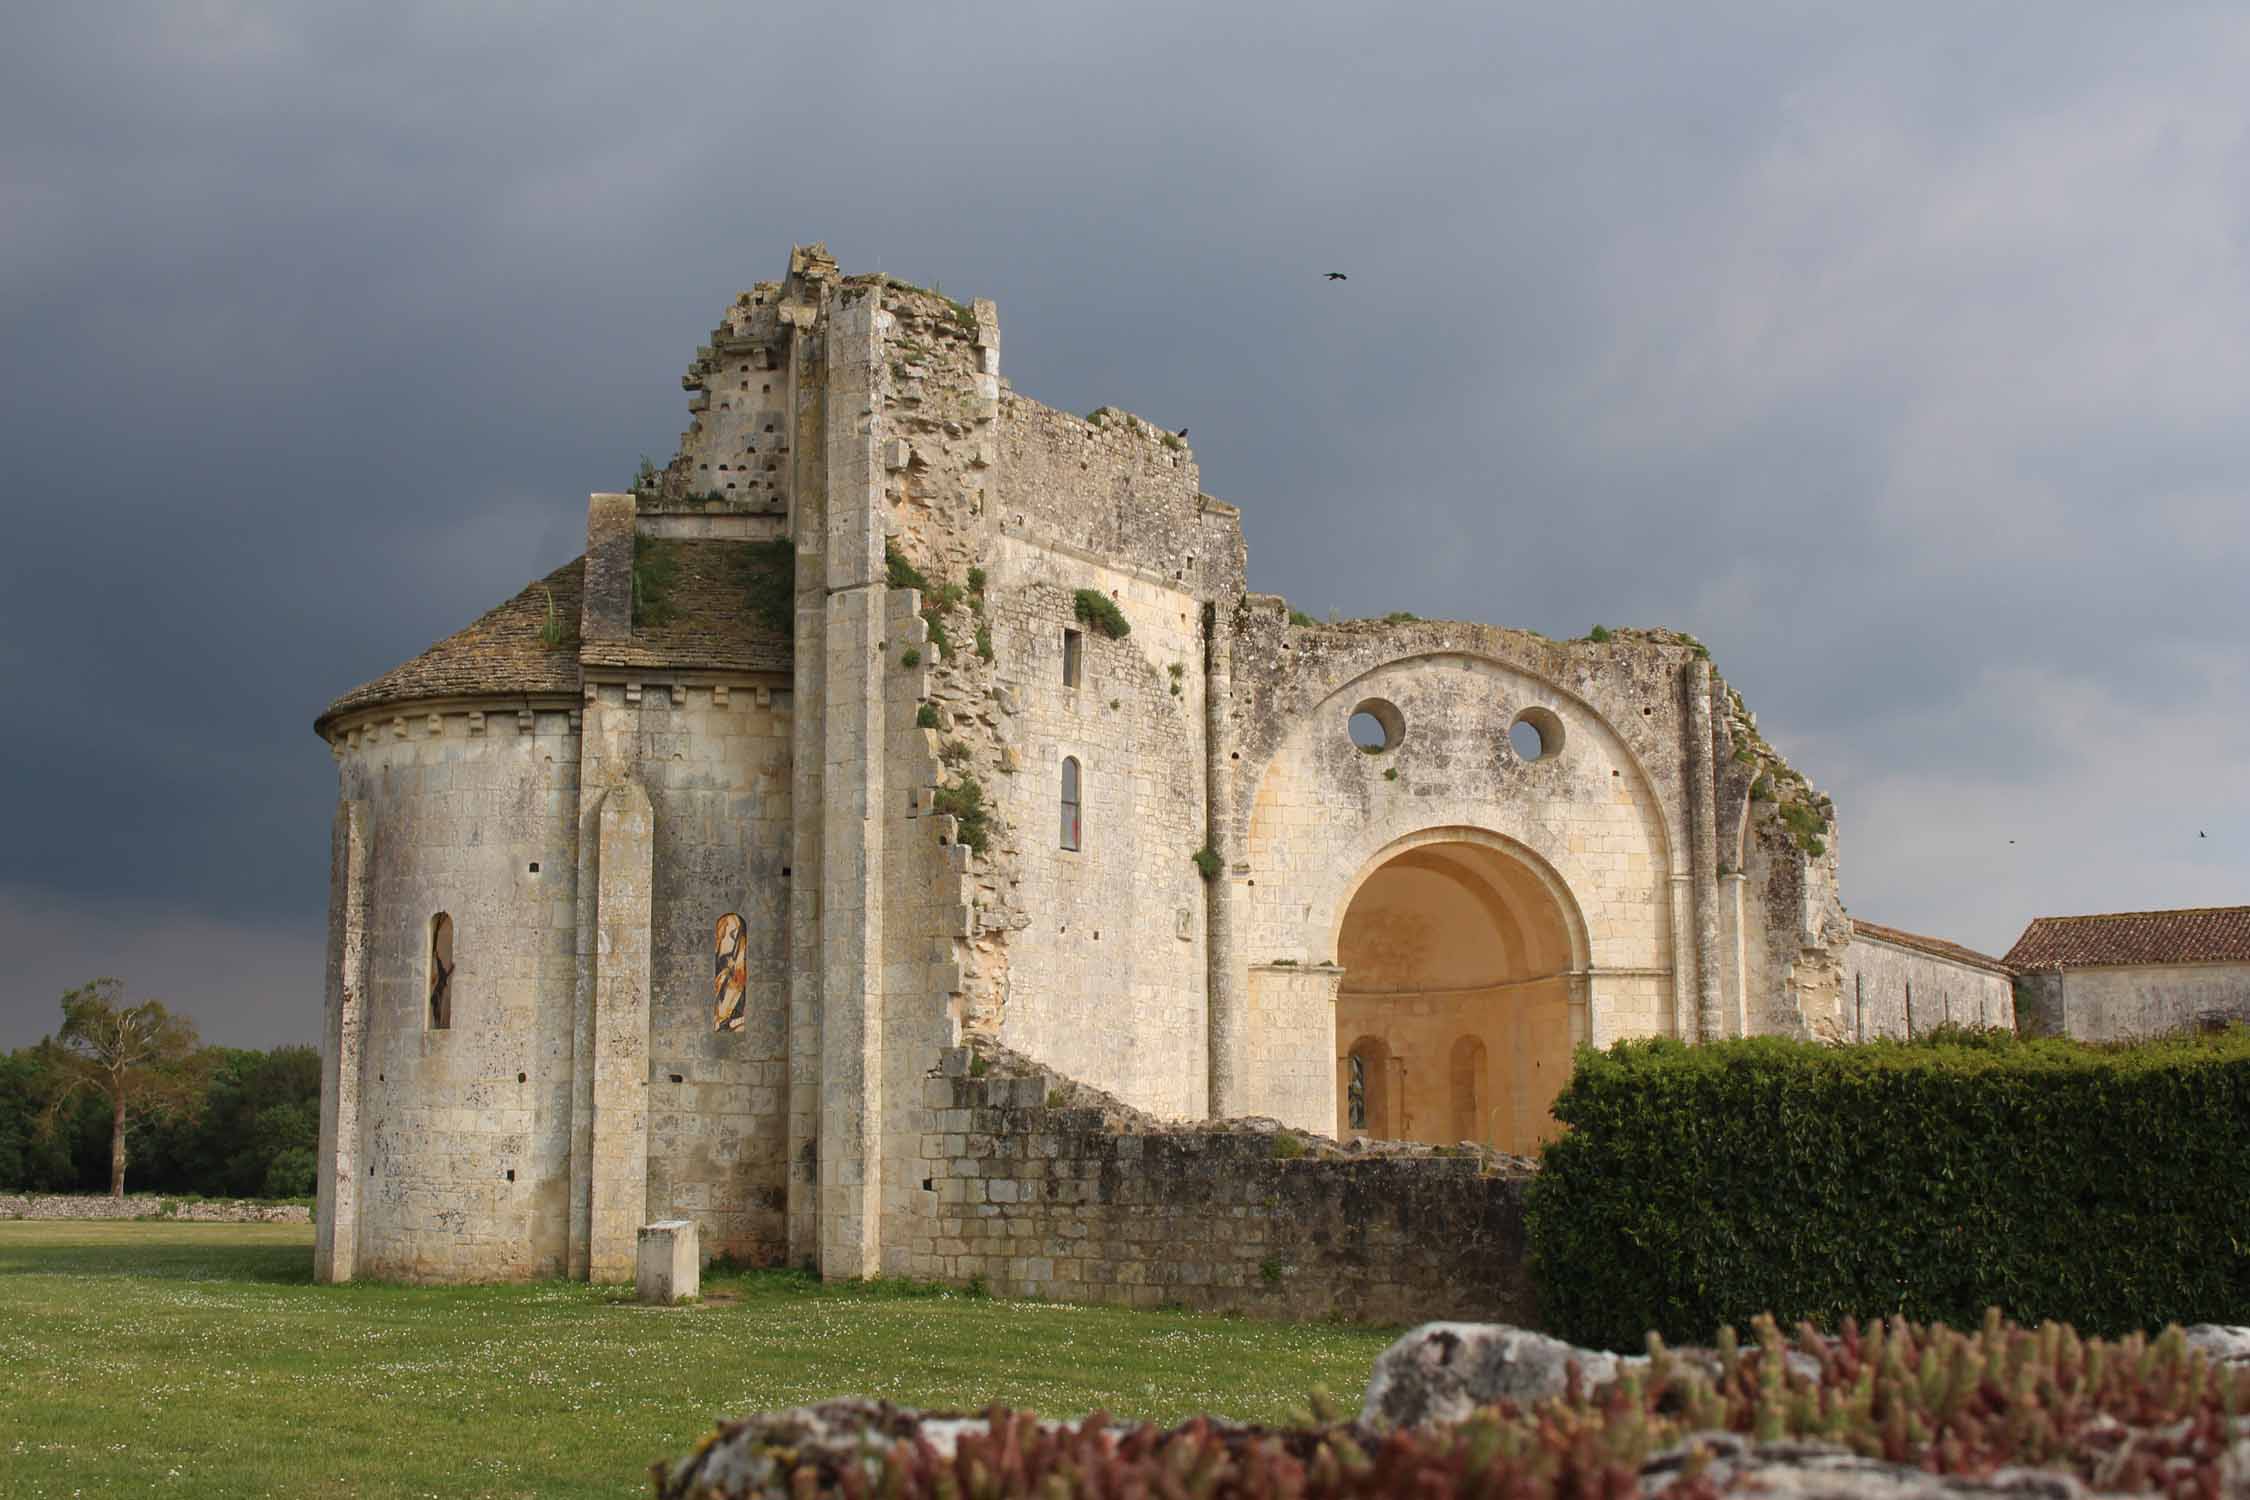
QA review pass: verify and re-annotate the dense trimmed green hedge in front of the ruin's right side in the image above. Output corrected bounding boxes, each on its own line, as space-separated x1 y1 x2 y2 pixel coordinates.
1526 1028 2250 1349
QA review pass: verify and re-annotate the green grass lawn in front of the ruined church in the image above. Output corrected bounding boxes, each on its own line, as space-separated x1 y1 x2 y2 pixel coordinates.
0 1221 1393 1496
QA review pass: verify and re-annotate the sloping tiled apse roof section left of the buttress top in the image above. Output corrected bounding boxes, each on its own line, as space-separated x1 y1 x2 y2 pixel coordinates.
313 558 585 733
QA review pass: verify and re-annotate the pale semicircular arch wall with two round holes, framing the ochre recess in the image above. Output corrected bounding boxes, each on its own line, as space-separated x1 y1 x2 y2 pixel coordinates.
1233 652 1679 1120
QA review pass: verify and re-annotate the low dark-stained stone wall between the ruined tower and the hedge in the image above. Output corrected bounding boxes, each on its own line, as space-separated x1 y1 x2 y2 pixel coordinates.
911 1043 1535 1325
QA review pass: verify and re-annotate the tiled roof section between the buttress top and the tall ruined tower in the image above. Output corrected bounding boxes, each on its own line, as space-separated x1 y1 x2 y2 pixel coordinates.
585 540 797 672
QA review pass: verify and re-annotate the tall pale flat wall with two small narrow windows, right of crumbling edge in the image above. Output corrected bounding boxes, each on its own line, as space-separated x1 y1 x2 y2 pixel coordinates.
970 391 1242 1118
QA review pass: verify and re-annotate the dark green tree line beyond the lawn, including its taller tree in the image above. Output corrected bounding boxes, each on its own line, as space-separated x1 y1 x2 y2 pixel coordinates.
0 978 320 1199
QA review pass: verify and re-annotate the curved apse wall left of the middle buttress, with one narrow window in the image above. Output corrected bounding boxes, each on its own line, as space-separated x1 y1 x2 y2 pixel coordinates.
338 708 578 1280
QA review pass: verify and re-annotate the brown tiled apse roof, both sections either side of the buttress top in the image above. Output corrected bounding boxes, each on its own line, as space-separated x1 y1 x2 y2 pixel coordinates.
313 540 792 733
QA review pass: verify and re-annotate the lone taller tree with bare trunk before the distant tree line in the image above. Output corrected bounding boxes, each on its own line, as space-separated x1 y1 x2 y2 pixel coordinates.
41 978 203 1199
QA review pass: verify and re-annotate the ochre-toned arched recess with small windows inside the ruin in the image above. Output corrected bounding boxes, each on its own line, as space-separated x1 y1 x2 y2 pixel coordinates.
1337 837 1582 1154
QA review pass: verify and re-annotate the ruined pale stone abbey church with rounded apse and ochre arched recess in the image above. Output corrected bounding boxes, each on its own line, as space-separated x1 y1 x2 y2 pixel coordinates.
317 247 2009 1295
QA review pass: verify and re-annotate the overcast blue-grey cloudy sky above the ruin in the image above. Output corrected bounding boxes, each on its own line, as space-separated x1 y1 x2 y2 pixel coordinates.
0 0 2250 1046
